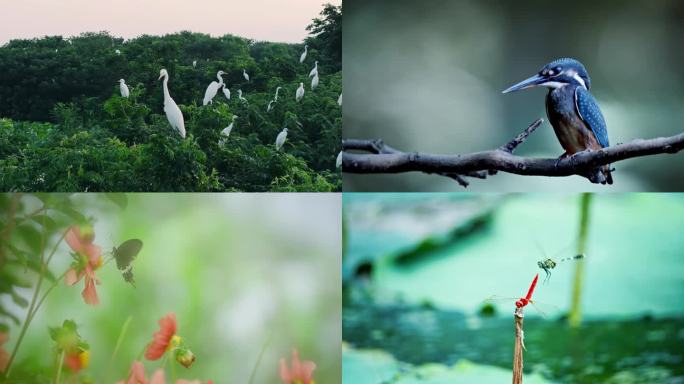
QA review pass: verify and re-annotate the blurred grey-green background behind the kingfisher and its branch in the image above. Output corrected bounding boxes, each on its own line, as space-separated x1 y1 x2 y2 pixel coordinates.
343 0 684 192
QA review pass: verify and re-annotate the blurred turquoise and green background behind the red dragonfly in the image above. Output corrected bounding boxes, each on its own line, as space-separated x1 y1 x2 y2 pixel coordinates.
343 193 684 384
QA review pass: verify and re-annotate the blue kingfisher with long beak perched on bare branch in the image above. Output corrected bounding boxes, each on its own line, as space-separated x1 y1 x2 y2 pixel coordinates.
503 58 613 184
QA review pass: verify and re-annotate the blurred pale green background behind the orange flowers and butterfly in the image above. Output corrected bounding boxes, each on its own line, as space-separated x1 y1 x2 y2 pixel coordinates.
6 194 341 383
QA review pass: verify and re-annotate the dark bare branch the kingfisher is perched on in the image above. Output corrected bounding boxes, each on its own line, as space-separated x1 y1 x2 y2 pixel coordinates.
342 119 684 187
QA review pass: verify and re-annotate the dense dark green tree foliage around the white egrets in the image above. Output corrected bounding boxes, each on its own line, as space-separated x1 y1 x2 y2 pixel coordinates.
0 5 342 191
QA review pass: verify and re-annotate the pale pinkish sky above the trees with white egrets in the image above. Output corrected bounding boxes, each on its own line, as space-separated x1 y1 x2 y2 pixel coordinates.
0 0 342 45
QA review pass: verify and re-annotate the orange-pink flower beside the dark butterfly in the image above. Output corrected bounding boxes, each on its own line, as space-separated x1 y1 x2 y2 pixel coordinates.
64 226 102 305
